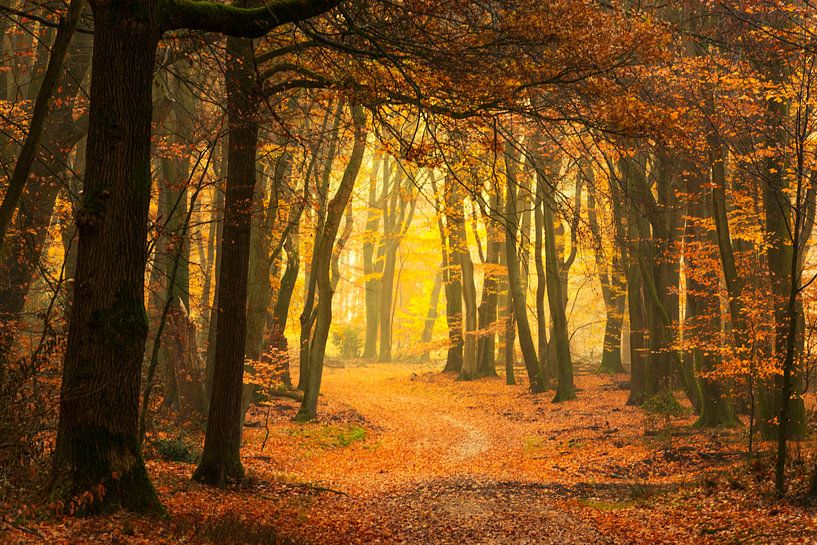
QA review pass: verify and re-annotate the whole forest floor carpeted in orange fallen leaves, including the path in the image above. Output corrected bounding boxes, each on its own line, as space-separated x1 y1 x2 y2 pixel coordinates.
0 362 817 545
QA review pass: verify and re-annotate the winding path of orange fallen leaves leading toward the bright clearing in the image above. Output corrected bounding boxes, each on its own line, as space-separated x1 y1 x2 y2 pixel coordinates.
239 363 626 544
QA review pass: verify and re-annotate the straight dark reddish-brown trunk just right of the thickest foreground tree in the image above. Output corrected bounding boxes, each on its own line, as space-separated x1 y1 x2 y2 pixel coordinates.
193 33 258 487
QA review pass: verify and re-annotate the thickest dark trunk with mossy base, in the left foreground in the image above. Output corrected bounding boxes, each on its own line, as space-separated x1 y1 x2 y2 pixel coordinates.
51 3 161 511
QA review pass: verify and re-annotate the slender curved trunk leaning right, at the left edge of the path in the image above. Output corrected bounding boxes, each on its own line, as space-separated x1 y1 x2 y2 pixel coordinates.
296 105 368 420
